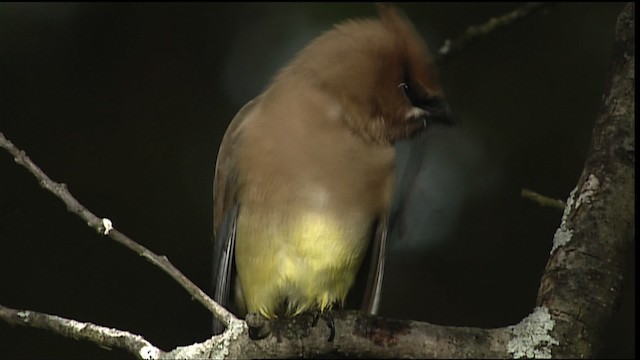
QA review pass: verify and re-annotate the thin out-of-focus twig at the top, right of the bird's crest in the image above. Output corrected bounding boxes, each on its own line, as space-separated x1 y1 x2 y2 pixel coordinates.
436 2 553 64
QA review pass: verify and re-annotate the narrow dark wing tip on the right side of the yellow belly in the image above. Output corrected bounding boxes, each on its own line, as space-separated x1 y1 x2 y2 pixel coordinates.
361 215 388 315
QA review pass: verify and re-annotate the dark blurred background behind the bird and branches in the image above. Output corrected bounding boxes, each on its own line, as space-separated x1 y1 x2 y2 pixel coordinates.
0 3 635 358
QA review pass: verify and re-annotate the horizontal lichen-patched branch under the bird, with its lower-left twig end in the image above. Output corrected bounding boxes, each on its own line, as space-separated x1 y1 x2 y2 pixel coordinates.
0 306 554 359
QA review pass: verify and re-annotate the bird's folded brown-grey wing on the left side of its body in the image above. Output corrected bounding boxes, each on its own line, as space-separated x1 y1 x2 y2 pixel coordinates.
212 99 257 333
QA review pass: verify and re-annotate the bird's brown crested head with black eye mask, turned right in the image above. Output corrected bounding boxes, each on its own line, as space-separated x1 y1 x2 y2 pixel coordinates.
278 5 450 144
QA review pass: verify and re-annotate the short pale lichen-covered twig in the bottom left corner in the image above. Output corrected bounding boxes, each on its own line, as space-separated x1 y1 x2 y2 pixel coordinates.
0 305 163 359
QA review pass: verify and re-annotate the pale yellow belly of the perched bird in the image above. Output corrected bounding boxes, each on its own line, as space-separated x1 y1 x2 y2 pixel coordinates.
236 209 371 318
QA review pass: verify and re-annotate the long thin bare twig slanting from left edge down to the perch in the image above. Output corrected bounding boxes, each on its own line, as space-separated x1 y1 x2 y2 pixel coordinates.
0 132 237 325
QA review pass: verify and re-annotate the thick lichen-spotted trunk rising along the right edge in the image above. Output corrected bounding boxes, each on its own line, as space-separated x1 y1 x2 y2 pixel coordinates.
537 4 635 358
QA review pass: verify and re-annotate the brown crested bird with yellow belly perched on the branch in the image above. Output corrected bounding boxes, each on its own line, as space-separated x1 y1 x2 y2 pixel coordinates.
213 6 448 334
